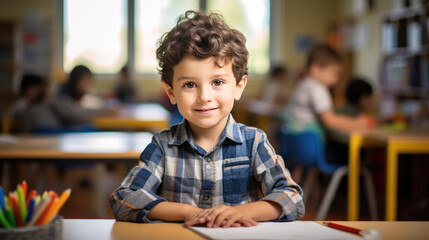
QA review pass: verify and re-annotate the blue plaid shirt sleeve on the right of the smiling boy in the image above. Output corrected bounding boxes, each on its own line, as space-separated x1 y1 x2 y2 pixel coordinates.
253 130 305 220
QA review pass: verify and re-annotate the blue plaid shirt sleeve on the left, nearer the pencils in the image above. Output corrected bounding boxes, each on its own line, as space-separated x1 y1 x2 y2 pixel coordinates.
110 135 165 222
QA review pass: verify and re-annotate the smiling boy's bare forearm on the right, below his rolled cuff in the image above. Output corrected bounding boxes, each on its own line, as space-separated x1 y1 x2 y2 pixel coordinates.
234 200 282 221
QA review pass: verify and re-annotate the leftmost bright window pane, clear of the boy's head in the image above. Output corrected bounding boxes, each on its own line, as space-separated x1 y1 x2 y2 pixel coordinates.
63 0 128 73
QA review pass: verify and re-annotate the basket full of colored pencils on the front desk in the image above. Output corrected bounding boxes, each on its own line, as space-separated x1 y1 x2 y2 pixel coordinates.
0 181 71 239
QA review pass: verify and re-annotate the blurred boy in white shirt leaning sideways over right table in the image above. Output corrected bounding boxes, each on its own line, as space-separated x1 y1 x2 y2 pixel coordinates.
284 44 370 139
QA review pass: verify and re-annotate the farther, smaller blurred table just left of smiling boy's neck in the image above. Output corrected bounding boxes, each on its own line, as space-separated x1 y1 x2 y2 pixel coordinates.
92 103 170 131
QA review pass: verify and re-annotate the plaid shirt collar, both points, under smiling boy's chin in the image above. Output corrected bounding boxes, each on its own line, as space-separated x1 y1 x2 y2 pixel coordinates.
169 114 243 146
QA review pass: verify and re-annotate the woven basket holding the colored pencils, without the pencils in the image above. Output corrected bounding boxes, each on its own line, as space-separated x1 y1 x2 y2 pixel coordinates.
0 216 63 240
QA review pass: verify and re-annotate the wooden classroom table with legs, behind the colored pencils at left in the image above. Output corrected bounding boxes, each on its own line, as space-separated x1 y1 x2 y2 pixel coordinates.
0 132 152 218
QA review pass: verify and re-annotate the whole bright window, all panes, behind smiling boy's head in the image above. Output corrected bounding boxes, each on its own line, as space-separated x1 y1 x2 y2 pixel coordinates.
63 0 270 74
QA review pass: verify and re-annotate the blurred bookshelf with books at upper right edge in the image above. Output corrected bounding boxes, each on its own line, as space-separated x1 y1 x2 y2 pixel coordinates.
380 4 429 122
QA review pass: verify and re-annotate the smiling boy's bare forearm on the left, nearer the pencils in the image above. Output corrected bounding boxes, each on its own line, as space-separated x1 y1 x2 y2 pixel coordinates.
147 201 201 221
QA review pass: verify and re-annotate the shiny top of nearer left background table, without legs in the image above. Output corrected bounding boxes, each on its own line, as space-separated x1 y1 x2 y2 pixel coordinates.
0 132 152 159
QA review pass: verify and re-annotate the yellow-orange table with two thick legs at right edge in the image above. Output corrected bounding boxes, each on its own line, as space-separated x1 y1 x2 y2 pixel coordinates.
346 129 429 221
